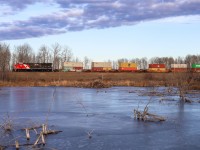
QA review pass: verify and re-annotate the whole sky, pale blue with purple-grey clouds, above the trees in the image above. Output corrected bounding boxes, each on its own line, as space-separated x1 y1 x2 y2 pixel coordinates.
0 0 200 61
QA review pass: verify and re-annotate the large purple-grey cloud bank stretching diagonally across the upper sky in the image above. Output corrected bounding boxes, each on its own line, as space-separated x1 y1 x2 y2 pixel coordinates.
0 0 200 40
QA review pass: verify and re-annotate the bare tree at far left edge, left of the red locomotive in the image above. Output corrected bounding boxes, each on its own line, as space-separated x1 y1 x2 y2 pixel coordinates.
0 43 11 80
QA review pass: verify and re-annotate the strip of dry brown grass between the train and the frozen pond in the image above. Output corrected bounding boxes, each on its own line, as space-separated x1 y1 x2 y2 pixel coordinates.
0 72 200 89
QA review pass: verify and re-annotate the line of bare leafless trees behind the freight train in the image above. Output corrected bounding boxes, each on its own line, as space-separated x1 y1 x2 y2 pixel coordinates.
0 43 200 75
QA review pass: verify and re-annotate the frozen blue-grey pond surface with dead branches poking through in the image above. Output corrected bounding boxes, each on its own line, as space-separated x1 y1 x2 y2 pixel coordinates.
0 87 200 150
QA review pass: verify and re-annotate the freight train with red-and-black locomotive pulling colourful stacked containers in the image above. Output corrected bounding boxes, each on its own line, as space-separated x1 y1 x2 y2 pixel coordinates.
13 62 200 73
